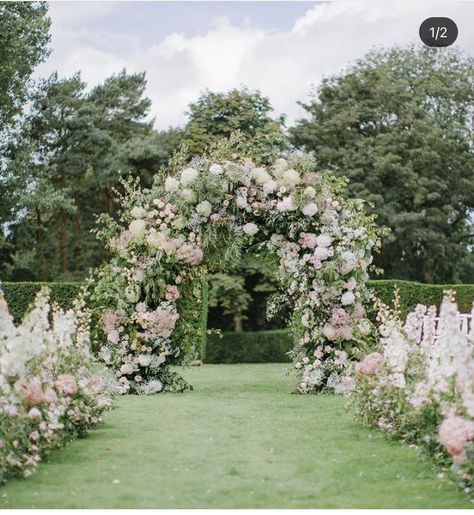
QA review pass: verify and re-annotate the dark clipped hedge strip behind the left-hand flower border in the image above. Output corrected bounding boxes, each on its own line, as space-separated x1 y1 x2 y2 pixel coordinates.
1 282 84 321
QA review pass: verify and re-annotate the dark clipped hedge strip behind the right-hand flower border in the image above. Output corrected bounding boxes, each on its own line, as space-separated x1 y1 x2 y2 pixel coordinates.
369 279 474 316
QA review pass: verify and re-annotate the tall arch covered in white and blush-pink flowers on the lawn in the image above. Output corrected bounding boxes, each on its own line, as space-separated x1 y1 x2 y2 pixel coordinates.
91 151 379 394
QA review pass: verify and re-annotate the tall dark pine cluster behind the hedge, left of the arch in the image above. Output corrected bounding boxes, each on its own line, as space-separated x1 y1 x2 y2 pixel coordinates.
3 71 161 280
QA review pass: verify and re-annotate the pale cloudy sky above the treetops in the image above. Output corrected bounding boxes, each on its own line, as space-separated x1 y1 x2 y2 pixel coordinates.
35 0 474 129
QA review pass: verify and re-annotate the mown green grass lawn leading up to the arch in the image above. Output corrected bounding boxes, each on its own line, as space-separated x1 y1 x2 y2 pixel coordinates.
0 364 472 508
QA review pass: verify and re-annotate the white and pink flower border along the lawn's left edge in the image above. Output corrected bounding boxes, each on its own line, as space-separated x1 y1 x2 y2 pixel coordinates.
0 290 115 481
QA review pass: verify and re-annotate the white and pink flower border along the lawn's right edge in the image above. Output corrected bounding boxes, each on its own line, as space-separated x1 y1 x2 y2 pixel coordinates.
350 292 474 491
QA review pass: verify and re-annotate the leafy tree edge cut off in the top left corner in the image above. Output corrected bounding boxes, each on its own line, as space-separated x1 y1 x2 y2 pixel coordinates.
0 2 50 129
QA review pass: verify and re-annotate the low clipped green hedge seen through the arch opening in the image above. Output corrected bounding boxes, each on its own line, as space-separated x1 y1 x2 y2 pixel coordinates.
205 329 293 363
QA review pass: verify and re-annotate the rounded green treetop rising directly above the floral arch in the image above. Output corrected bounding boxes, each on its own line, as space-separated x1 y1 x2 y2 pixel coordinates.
183 87 286 163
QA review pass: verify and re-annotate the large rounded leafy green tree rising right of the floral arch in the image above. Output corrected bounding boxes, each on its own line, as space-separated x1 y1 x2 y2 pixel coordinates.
291 47 474 283
